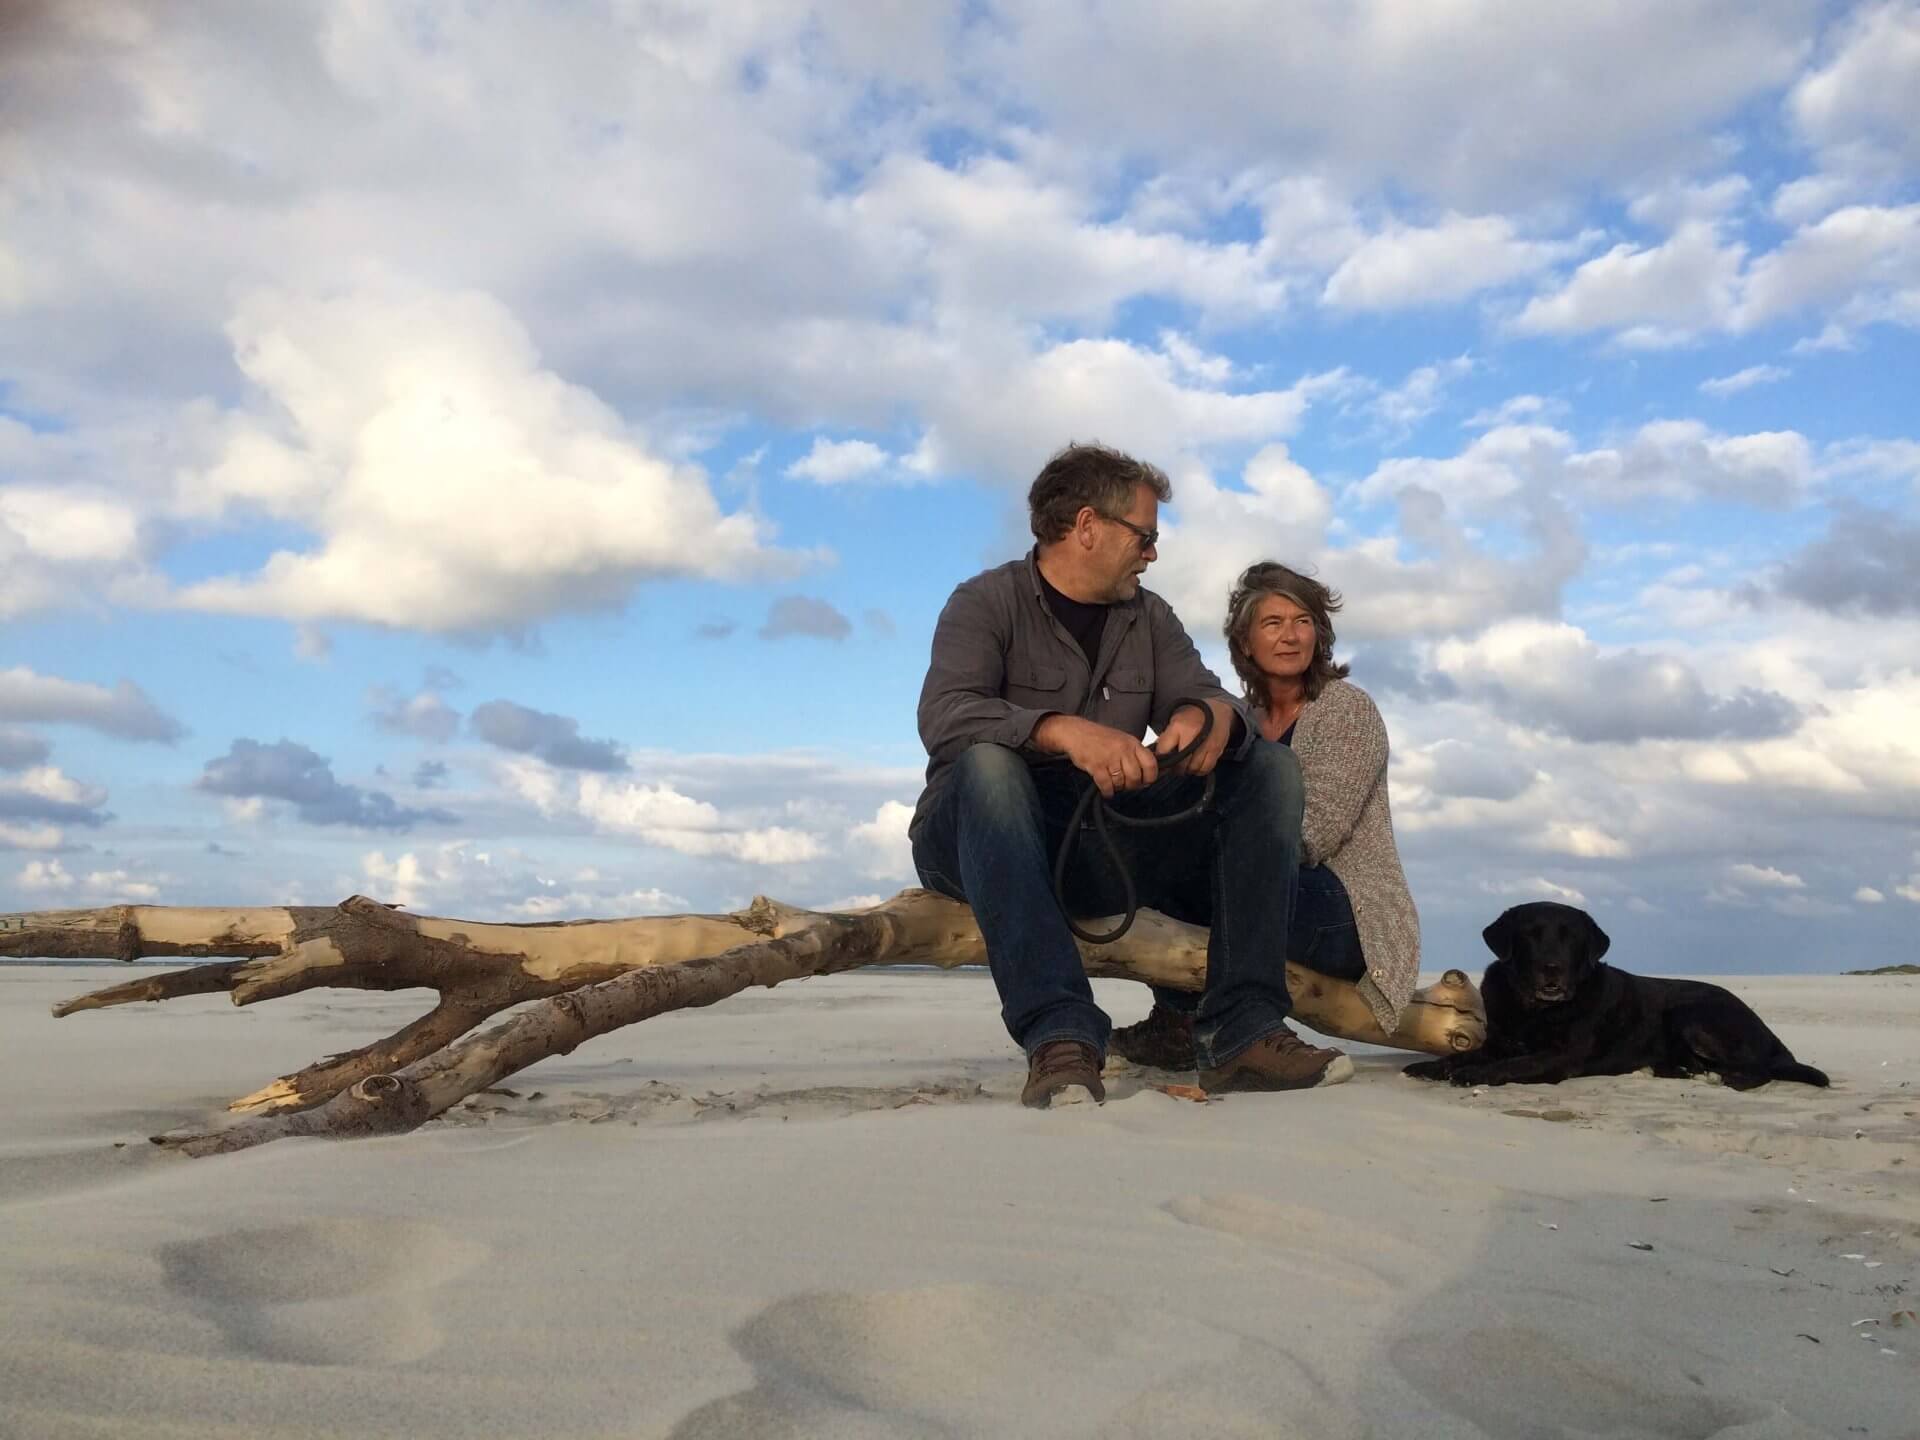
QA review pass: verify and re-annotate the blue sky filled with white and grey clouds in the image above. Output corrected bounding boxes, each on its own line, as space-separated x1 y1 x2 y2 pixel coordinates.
0 0 1920 973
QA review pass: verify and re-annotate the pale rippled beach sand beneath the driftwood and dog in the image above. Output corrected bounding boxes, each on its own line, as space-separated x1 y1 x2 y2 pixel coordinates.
0 968 1920 1440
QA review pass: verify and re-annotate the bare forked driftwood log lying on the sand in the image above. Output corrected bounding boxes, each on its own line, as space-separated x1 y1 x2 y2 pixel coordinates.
0 889 1486 1156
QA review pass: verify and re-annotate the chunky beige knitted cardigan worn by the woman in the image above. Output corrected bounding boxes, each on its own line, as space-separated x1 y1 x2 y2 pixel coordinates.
1292 680 1421 1035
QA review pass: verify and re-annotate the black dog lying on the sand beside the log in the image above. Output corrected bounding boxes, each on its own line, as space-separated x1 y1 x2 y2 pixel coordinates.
1405 900 1826 1091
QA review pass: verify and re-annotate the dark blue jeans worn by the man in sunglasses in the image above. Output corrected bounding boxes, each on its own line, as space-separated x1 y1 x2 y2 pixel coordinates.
914 743 1306 1068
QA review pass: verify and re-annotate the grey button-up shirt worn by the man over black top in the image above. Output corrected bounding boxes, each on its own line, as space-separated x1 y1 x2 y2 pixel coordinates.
908 551 1254 833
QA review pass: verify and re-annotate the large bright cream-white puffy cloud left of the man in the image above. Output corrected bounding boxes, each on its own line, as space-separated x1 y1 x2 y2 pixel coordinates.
165 294 794 632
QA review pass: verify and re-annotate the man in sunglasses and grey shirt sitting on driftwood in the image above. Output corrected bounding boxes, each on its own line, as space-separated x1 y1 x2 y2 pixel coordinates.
908 445 1354 1108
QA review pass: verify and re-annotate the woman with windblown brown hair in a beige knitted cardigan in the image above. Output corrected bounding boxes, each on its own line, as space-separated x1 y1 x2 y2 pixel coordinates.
1112 561 1421 1069
